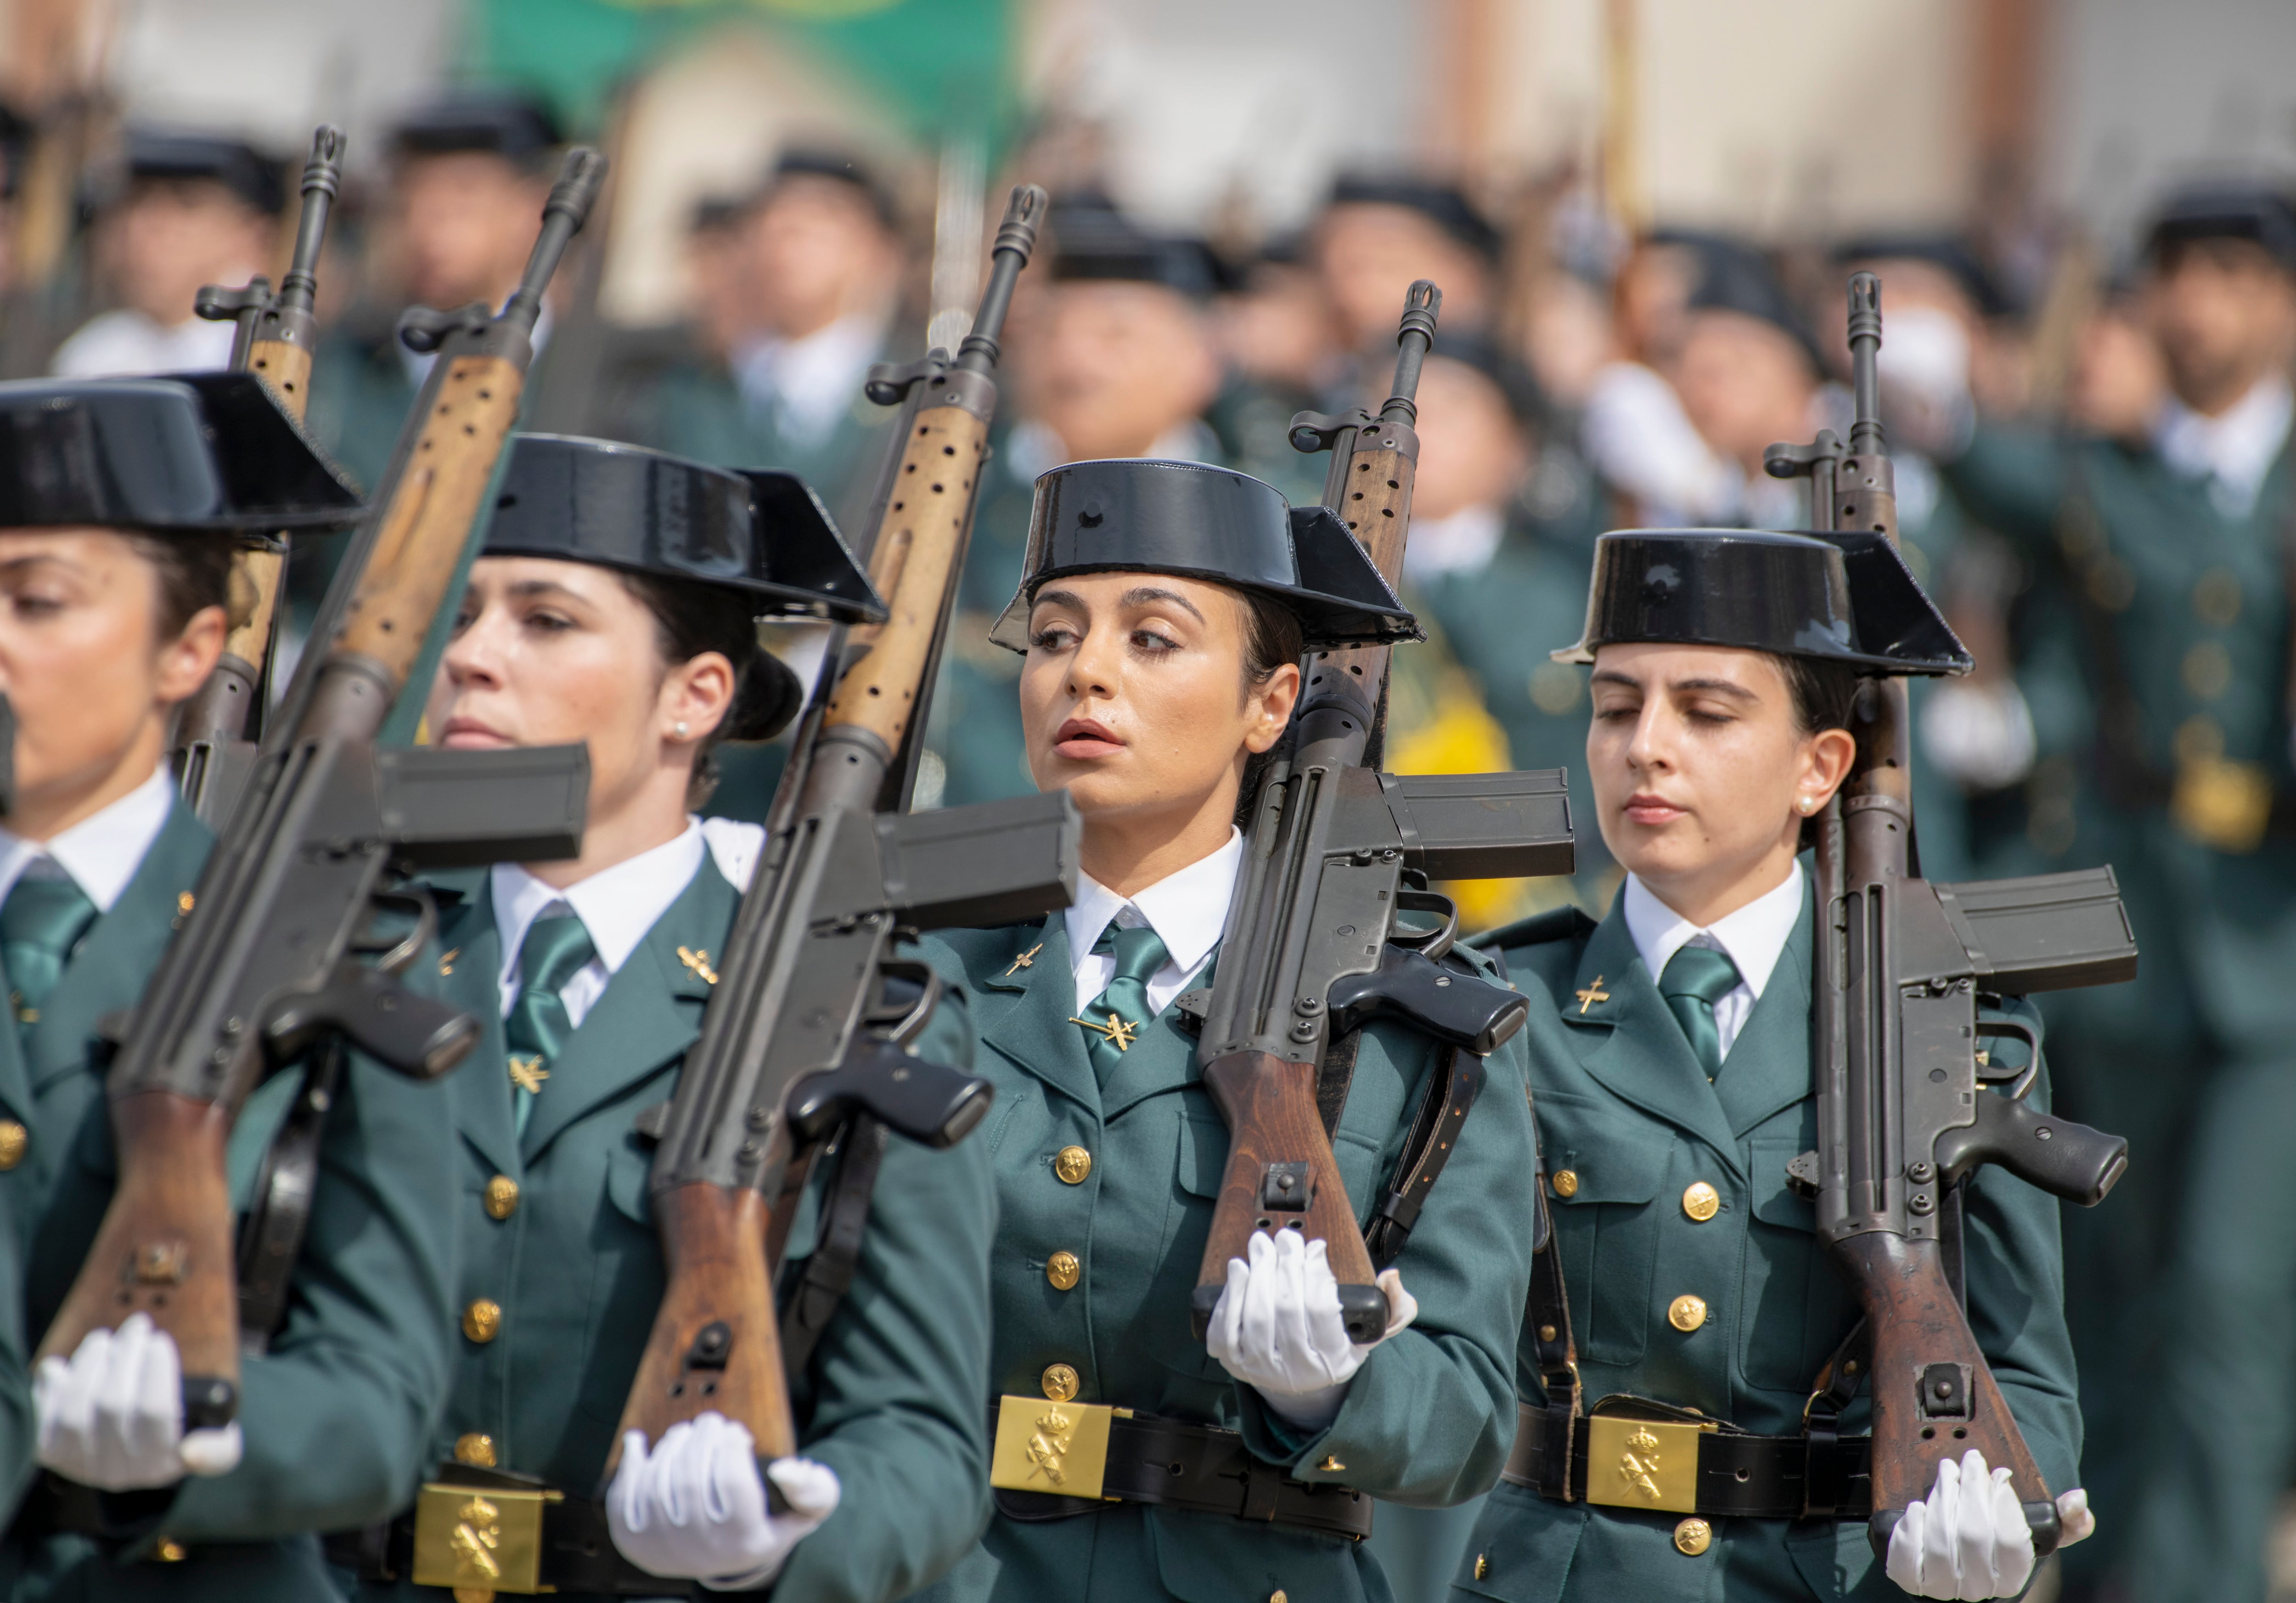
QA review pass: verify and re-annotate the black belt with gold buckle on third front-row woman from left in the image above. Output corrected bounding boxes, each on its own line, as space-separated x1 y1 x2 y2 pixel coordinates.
990 1396 1371 1539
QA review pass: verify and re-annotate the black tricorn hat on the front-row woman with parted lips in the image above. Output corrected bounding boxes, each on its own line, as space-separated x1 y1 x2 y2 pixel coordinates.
990 459 1424 652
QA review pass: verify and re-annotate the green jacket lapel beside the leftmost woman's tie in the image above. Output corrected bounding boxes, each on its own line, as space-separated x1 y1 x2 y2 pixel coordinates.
23 802 216 1093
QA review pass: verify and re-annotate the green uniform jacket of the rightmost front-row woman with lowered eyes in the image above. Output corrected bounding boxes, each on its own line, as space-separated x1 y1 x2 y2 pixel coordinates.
1453 898 2080 1603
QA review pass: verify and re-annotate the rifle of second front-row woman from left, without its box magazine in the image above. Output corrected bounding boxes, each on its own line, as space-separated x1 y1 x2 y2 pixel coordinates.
602 186 1052 1484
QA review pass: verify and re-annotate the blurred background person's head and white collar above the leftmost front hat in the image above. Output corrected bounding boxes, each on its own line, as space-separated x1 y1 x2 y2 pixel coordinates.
51 129 285 379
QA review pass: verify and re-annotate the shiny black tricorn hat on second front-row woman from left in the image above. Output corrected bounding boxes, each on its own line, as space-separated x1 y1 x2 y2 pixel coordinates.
487 434 884 622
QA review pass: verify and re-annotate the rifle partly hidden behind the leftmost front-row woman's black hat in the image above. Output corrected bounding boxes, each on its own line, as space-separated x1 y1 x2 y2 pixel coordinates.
174 124 344 824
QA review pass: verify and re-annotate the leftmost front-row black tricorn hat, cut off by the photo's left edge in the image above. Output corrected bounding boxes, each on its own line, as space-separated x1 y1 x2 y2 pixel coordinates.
0 372 360 533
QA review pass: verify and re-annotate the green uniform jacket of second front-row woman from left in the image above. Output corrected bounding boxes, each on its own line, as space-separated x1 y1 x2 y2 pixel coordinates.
365 857 996 1603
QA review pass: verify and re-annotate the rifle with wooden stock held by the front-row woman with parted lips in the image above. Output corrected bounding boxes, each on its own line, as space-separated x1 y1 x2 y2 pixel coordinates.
1182 280 1573 1343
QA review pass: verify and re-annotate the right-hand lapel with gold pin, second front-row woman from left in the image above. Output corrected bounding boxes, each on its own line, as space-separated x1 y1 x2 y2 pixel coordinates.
519 857 735 1164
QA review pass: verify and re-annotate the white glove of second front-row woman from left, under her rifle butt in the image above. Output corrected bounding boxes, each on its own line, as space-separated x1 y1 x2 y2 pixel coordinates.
606 1412 840 1592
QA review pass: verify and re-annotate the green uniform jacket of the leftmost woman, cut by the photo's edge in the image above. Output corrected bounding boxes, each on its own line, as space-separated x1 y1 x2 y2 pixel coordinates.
0 804 452 1601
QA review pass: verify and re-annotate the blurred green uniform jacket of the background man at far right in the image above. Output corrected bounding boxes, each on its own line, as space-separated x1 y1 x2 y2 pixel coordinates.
1947 427 2296 1056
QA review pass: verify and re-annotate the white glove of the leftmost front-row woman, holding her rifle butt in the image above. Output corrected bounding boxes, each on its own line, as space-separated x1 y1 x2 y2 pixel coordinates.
32 1314 243 1493
